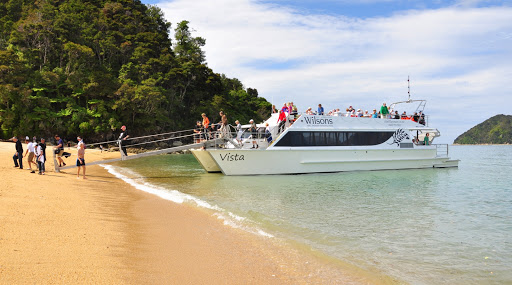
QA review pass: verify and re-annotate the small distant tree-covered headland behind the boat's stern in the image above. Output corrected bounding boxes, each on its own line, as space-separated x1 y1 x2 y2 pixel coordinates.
454 115 512 144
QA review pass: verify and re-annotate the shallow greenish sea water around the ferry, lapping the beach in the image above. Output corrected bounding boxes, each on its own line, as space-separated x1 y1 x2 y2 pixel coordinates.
108 146 512 284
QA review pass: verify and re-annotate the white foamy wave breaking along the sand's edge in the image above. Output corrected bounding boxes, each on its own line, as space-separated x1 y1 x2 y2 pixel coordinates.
100 164 274 238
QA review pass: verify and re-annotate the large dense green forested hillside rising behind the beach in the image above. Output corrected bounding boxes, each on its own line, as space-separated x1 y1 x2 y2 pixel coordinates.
0 0 270 141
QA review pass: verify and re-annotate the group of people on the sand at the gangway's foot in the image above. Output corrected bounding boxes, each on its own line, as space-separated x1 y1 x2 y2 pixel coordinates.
12 135 87 179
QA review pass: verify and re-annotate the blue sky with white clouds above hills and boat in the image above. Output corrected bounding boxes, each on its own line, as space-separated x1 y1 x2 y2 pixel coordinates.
143 0 512 143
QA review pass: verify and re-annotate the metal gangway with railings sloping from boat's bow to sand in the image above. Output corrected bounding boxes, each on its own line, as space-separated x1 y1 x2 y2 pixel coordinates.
53 130 226 172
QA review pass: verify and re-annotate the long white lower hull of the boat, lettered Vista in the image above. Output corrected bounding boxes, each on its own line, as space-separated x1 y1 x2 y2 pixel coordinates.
199 147 458 175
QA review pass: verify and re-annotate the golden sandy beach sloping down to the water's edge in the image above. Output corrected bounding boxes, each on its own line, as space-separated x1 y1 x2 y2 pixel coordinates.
0 142 394 284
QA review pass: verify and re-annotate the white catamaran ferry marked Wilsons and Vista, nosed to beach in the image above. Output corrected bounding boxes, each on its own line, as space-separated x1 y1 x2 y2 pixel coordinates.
192 99 459 175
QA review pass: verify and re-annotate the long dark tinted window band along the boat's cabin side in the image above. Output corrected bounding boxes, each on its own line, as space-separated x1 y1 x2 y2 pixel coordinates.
276 131 394 146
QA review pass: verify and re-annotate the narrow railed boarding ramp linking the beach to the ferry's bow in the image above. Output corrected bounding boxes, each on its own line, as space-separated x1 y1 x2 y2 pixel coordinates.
53 129 228 172
